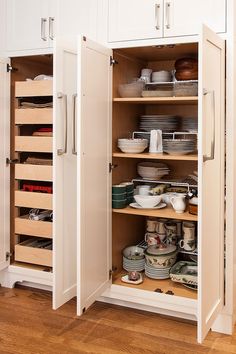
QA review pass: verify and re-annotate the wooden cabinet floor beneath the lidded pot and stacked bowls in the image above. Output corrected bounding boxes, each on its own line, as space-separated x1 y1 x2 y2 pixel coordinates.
112 271 197 300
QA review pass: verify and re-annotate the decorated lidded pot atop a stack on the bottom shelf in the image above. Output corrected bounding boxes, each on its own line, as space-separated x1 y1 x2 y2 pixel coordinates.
144 244 177 269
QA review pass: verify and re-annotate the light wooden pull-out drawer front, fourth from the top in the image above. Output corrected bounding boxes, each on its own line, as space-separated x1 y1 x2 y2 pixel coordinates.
15 164 52 182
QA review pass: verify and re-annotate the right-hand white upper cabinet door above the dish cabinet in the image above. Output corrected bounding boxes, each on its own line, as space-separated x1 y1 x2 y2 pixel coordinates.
164 0 226 37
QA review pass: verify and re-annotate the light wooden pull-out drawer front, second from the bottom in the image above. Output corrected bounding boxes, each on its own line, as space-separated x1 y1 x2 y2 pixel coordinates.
15 217 52 238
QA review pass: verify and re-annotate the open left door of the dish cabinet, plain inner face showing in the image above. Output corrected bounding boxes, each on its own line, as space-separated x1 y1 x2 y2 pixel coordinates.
77 37 112 315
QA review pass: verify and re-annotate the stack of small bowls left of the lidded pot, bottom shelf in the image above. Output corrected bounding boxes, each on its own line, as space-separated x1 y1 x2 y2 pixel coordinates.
123 246 145 272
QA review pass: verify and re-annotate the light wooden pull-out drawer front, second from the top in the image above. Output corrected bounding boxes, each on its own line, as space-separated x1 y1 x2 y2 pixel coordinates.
15 108 53 124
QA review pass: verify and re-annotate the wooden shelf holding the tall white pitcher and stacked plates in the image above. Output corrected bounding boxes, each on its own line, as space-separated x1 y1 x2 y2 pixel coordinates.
112 152 198 161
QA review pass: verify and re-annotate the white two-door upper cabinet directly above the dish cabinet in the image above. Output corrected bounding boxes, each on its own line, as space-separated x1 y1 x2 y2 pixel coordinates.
108 0 226 42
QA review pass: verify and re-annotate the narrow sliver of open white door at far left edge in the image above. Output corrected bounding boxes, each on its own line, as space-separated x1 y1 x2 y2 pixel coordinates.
0 58 10 271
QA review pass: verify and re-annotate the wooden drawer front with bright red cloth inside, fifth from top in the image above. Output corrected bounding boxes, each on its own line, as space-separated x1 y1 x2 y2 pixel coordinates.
15 191 53 210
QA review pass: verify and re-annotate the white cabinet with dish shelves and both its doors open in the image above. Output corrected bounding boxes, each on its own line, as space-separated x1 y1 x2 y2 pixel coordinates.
77 26 225 342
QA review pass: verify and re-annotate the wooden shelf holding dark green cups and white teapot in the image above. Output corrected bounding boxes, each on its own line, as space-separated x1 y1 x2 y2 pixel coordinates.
112 206 197 221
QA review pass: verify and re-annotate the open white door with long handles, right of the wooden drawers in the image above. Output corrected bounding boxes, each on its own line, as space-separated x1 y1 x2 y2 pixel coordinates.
53 38 77 309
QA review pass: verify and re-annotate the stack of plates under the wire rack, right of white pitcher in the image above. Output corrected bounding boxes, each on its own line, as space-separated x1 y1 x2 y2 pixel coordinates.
163 139 197 155
